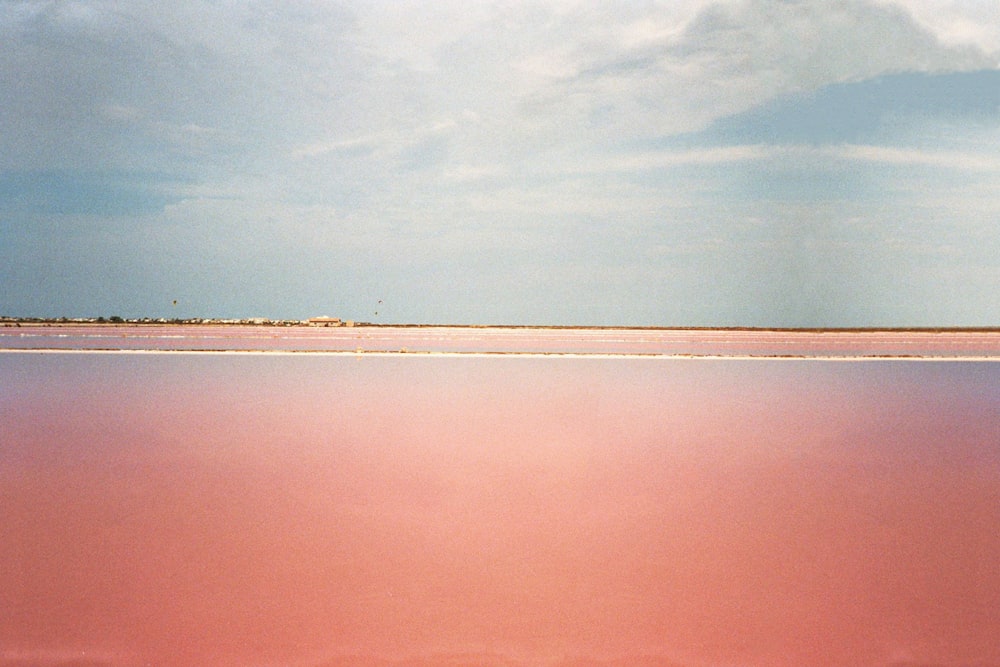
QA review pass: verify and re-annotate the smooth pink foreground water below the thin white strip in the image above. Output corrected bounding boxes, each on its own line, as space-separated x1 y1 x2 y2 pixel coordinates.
0 354 1000 667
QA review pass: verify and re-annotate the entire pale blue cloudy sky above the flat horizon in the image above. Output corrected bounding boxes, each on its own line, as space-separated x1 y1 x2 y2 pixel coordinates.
0 0 1000 326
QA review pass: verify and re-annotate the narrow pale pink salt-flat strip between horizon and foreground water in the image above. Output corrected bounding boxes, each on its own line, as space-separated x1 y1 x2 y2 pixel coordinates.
0 323 1000 360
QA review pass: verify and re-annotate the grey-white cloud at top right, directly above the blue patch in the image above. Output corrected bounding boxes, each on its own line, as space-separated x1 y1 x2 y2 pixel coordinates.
663 0 991 126
